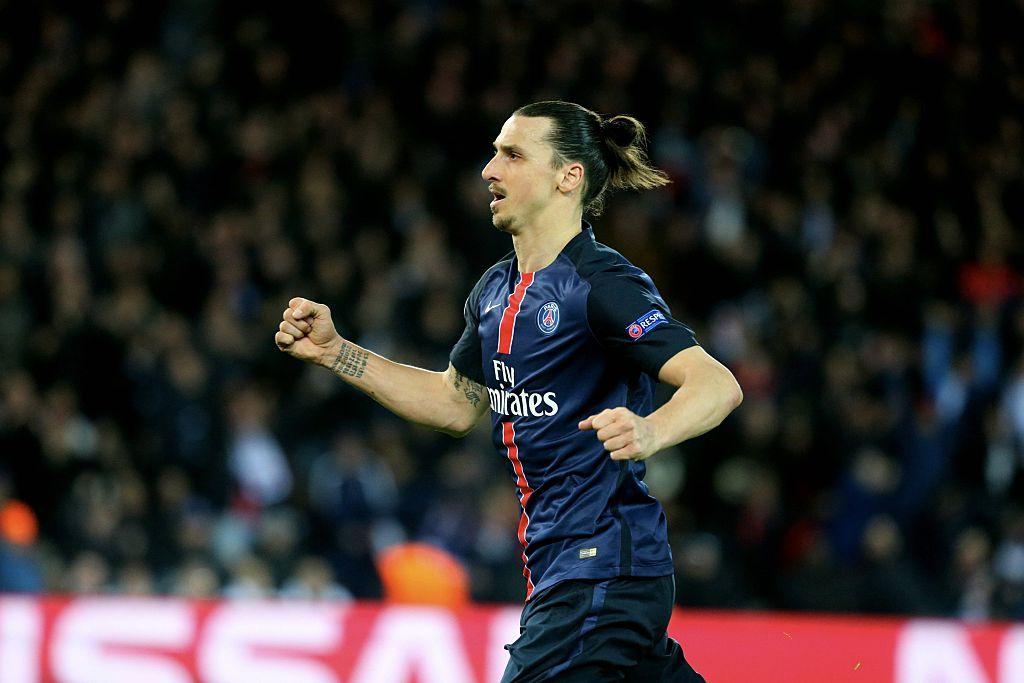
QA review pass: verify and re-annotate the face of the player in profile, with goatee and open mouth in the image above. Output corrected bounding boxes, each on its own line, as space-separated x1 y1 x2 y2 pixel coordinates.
480 116 558 234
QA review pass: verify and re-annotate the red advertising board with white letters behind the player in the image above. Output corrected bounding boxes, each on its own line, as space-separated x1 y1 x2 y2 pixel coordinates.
0 597 1024 683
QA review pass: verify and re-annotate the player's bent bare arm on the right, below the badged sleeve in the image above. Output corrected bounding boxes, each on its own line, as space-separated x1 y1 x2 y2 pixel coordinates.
580 346 743 460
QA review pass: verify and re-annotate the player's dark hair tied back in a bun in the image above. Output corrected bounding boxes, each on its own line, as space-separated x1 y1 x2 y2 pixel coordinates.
515 100 669 216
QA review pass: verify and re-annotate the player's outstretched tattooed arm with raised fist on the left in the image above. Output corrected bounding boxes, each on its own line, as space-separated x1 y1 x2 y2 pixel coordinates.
274 298 490 436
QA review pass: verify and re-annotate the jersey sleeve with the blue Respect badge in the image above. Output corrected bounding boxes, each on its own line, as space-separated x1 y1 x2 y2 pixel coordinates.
587 270 697 379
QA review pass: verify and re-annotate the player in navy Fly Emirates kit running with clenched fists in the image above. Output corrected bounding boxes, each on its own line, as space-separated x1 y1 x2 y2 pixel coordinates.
274 101 742 683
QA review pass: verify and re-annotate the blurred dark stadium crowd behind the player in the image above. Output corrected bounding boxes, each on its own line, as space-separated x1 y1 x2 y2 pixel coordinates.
0 0 1024 618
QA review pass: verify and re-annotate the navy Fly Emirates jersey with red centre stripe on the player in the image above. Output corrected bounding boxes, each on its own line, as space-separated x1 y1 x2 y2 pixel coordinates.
452 224 696 600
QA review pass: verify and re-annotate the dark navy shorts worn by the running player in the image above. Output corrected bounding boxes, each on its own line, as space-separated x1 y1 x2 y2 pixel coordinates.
502 575 705 683
